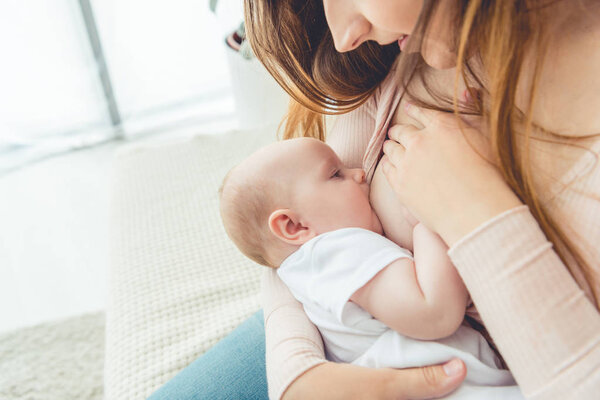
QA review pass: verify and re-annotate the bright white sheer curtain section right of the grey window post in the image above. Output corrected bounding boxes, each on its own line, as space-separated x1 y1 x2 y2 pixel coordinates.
92 0 242 135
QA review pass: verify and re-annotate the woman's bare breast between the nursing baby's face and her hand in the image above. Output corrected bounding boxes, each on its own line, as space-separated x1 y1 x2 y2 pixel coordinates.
370 165 412 250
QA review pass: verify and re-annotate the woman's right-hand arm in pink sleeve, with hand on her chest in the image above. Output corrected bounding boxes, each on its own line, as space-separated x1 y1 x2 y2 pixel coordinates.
383 107 600 399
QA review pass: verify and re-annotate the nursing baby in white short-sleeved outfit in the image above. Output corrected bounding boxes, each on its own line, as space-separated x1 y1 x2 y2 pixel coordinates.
220 138 523 399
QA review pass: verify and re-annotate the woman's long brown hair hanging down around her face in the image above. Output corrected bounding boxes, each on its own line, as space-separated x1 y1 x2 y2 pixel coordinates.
245 0 600 307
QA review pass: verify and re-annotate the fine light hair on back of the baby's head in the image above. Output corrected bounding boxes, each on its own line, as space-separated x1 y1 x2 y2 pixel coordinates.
219 167 278 267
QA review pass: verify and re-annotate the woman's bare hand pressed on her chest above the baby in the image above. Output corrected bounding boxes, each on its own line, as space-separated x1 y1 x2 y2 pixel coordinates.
381 105 521 246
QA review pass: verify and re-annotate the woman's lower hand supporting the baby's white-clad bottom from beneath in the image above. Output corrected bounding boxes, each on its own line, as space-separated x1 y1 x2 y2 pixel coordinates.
283 359 467 400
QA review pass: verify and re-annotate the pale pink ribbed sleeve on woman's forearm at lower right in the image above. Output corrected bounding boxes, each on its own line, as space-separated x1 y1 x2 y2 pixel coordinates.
449 206 600 399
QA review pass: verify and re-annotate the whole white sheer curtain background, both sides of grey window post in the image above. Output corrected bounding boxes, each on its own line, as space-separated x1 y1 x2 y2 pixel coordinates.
0 0 242 172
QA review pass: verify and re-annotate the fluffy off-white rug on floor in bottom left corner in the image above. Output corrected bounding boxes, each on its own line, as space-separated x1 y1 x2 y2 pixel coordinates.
0 312 104 400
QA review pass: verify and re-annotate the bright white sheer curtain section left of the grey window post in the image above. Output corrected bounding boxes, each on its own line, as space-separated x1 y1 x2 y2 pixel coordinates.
0 0 110 172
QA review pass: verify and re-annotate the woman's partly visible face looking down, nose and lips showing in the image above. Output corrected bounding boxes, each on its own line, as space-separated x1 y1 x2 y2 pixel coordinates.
323 0 456 69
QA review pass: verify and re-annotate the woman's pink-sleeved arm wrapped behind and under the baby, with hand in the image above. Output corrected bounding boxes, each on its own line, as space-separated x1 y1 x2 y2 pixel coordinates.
262 100 466 400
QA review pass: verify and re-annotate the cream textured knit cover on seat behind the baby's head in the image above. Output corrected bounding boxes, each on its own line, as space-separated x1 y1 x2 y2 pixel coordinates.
104 127 275 400
